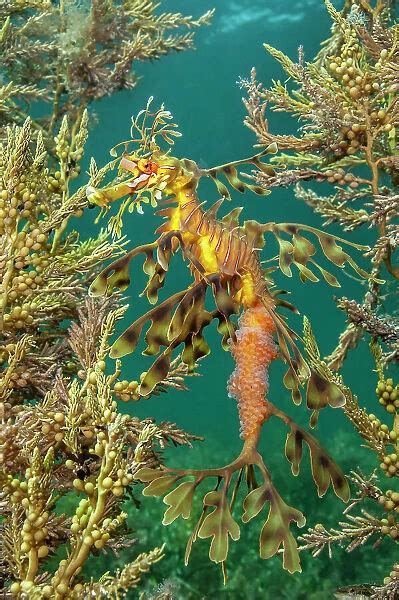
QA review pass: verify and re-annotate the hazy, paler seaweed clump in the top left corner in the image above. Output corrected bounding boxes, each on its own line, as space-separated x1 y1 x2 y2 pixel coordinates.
0 0 213 142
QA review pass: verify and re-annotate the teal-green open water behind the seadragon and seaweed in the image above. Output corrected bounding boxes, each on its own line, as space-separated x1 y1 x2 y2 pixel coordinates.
76 0 396 599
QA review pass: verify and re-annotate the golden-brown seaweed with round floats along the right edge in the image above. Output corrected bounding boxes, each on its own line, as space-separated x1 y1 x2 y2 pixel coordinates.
241 0 399 599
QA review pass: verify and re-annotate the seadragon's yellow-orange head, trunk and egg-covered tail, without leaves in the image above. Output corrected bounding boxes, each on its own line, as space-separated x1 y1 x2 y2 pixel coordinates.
89 149 286 439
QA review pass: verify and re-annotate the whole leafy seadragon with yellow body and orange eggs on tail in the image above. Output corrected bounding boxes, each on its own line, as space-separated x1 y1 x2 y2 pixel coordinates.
87 106 367 572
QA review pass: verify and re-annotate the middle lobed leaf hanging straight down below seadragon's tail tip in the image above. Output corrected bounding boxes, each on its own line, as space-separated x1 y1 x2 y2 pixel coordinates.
198 491 240 563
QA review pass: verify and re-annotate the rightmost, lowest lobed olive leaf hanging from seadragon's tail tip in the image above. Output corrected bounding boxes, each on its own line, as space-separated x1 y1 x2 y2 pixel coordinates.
260 487 306 573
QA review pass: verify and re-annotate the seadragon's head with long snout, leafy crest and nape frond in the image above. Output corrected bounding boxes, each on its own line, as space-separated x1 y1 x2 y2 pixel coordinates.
86 98 277 235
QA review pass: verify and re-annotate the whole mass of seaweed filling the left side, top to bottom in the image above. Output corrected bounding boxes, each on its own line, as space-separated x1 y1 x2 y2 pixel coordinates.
0 0 216 598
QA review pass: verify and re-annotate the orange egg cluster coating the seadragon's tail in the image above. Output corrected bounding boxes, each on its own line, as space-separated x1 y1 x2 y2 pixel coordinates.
227 305 277 440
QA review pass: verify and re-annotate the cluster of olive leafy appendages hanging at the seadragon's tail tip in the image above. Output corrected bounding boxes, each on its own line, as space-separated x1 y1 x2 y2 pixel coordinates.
135 457 305 573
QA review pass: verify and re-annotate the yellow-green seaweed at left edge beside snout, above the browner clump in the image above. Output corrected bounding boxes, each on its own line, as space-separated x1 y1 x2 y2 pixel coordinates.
0 112 118 404
